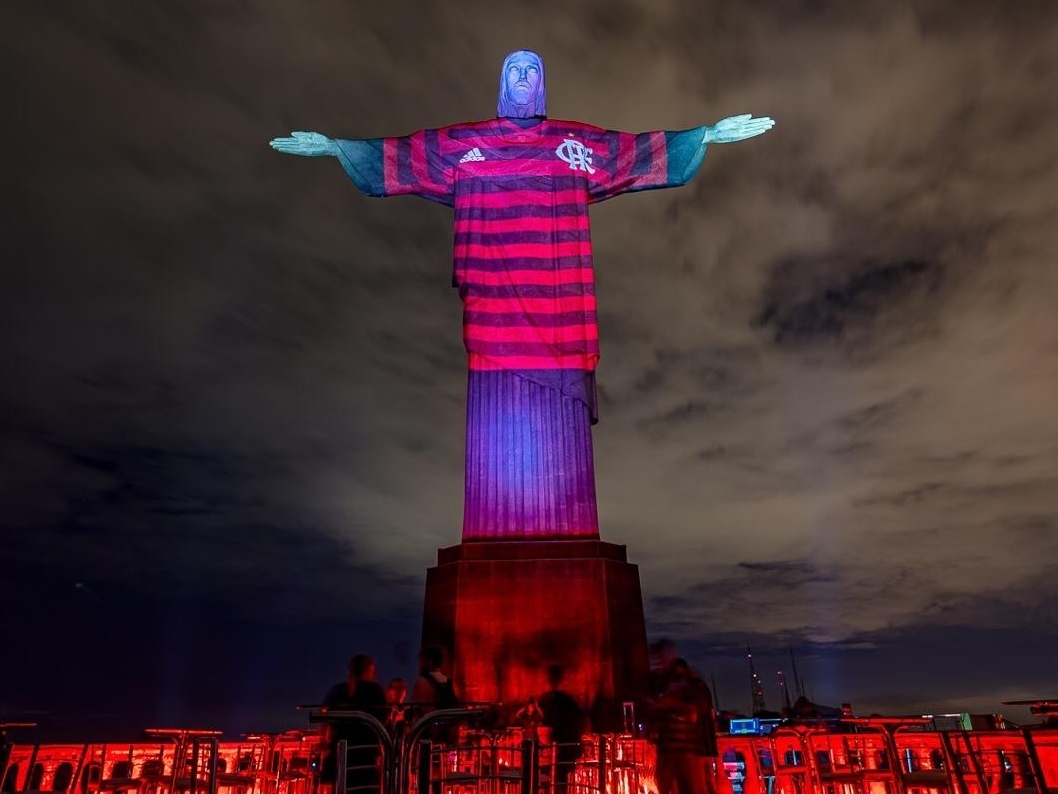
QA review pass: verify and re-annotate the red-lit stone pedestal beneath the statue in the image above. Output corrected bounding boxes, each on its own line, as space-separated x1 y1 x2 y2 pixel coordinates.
422 540 649 729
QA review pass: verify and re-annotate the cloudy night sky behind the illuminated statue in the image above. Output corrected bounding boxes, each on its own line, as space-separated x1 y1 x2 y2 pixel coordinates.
0 0 1058 730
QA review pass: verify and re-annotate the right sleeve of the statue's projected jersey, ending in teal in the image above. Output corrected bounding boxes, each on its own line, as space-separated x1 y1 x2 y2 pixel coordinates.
588 127 706 201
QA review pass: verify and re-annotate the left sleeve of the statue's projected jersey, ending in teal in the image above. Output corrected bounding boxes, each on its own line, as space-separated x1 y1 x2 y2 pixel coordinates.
335 129 455 206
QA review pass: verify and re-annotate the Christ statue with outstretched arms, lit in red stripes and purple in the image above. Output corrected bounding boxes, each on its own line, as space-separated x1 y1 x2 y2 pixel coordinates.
271 50 774 541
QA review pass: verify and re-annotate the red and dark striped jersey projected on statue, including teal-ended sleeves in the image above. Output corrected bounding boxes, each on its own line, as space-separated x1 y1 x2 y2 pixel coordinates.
338 119 705 372
